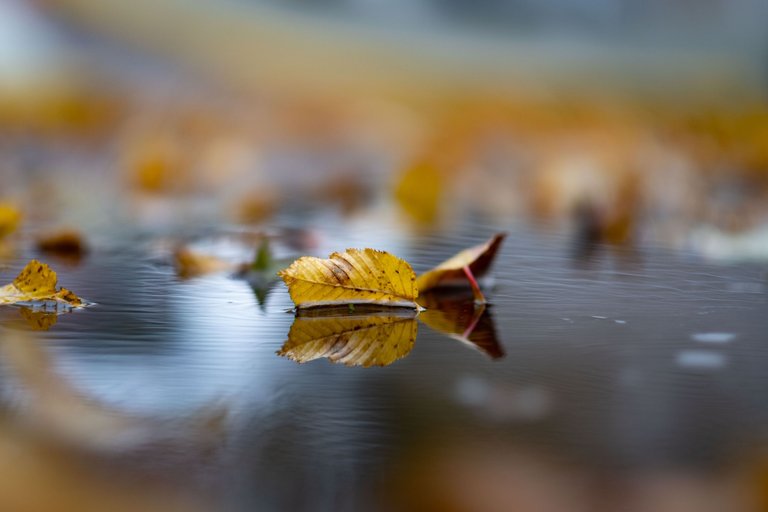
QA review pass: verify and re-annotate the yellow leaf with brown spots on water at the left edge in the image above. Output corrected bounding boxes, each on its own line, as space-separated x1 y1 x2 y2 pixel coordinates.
0 260 83 307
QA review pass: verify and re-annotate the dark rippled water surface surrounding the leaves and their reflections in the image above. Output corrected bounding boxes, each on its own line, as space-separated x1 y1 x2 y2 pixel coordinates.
0 215 768 511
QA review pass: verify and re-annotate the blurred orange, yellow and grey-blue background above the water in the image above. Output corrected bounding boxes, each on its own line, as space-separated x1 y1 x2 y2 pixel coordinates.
0 0 768 255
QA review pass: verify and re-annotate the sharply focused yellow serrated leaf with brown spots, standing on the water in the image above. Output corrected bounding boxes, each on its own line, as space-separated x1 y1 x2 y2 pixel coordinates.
278 249 419 309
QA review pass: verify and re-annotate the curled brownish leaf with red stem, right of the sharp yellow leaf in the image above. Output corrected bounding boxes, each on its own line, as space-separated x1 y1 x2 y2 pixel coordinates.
416 233 506 303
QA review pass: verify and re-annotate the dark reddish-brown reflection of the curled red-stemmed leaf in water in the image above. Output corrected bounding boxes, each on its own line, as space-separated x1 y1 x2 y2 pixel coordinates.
419 292 504 359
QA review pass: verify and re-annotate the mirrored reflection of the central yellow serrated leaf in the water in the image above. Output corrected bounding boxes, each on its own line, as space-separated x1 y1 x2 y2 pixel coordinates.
277 313 418 367
